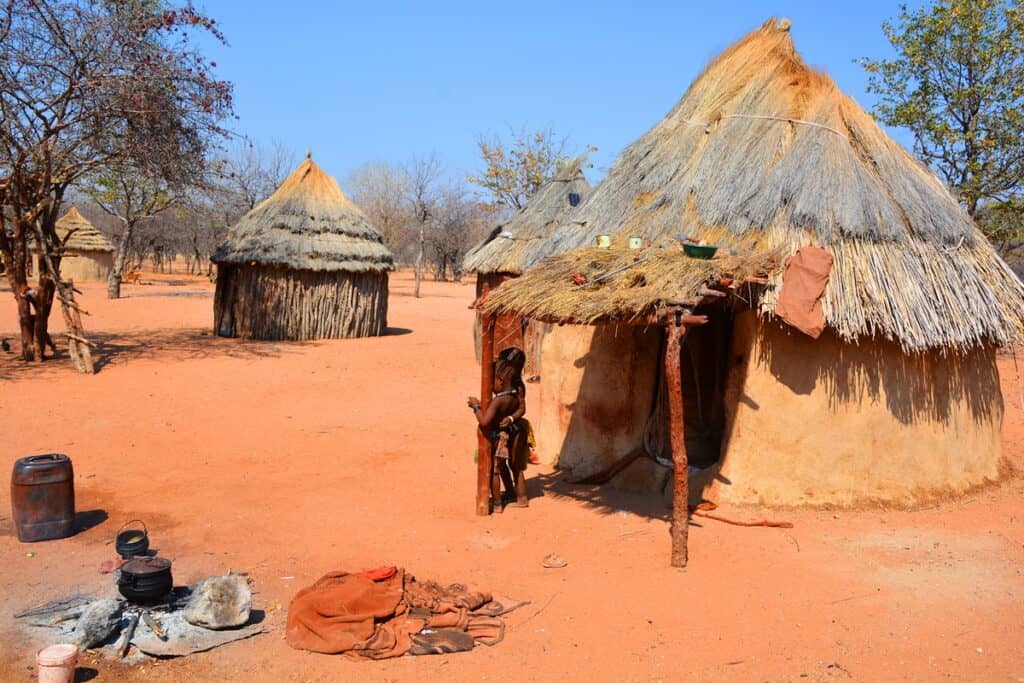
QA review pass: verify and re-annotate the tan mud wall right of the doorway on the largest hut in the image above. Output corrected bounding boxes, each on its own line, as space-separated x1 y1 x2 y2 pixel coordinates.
705 312 1002 505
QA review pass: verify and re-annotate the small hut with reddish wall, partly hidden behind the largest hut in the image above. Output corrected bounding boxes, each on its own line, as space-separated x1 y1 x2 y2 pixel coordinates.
463 157 591 374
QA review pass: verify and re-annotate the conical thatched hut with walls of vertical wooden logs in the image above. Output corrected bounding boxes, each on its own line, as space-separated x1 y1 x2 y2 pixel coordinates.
213 158 393 340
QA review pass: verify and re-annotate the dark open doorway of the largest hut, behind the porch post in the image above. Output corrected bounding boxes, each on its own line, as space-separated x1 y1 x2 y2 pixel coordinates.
644 305 734 469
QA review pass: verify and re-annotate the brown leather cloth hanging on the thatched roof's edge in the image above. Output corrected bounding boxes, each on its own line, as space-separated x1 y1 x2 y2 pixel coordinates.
775 247 833 339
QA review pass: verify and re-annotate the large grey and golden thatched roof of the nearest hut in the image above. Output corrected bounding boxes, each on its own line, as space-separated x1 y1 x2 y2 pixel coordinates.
486 19 1024 350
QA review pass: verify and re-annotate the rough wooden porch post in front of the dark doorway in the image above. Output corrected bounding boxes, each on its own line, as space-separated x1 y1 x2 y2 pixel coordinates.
665 319 690 567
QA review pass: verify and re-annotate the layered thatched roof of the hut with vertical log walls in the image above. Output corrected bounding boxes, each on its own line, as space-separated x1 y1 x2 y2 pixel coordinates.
212 158 394 272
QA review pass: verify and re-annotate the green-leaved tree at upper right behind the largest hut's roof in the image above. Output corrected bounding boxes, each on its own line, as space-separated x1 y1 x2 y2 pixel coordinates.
860 0 1024 217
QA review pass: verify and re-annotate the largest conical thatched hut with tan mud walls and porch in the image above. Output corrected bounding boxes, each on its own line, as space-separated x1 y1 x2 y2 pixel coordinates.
482 20 1024 507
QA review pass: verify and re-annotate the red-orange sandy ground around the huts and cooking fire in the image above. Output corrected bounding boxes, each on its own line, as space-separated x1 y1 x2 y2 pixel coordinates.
0 274 1024 681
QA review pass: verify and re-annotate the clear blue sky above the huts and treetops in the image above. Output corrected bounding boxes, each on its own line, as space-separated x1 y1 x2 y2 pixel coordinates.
199 0 919 180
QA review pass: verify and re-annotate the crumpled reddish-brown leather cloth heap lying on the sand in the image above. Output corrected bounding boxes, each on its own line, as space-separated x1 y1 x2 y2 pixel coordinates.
285 569 524 659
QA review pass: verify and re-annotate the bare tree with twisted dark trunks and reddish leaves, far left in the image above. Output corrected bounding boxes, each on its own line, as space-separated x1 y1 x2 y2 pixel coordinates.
0 0 231 372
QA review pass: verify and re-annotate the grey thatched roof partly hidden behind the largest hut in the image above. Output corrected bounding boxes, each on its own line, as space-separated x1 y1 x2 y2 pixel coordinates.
463 157 591 274
